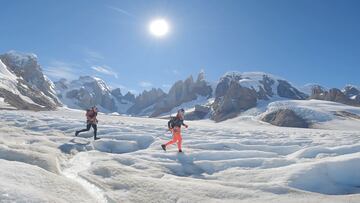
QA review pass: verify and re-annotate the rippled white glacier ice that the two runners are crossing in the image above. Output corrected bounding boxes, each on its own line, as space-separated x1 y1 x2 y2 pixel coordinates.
0 108 360 202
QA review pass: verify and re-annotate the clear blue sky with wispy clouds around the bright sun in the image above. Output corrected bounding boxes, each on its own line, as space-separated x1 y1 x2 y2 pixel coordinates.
0 0 360 92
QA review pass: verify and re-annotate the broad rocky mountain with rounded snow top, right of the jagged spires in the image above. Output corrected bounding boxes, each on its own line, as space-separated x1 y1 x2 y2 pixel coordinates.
212 72 307 121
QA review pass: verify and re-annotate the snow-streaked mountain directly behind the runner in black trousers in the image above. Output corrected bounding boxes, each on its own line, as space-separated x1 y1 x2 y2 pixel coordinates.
55 76 135 113
